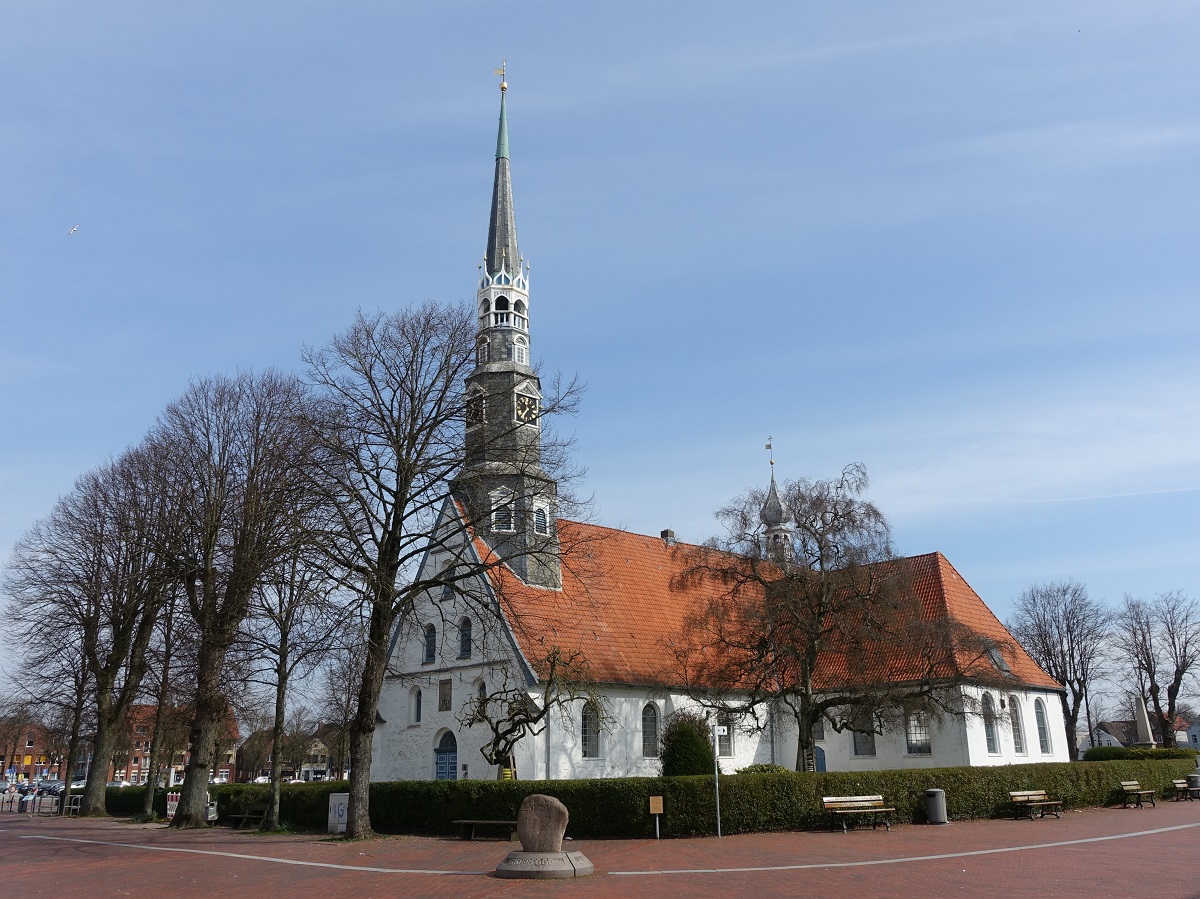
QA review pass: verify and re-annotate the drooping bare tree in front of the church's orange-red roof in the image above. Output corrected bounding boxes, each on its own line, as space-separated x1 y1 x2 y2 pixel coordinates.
673 465 1006 771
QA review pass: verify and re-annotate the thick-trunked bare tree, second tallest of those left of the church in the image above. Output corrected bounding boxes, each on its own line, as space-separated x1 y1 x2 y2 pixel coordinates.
150 372 319 827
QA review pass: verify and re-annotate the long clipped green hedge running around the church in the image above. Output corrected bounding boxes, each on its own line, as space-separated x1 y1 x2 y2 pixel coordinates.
108 756 1196 839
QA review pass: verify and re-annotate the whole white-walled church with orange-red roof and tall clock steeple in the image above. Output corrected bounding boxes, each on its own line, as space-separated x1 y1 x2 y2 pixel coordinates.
372 75 1070 780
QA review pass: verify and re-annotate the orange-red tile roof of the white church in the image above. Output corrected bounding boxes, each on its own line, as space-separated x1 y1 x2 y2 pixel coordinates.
475 521 1061 689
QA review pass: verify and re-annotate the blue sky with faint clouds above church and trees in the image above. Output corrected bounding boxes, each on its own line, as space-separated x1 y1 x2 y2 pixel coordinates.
0 0 1200 672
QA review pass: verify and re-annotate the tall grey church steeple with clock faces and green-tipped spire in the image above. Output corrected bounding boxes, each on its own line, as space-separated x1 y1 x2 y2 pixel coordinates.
455 68 560 587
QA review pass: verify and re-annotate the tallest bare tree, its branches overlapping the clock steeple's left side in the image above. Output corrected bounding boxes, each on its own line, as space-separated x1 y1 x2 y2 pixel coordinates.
306 304 578 838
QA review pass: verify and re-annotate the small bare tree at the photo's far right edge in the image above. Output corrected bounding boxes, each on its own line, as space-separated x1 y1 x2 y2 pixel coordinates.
1114 591 1200 747
